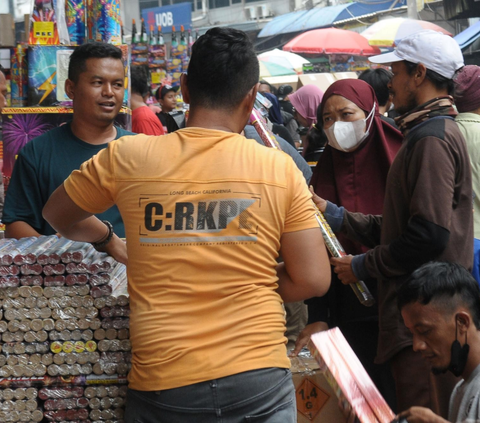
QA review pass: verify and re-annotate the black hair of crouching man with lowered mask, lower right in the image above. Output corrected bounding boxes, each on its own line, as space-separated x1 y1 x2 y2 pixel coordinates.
397 262 480 329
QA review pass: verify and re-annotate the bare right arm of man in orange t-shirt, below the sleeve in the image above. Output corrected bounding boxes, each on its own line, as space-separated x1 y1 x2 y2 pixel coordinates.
277 228 330 303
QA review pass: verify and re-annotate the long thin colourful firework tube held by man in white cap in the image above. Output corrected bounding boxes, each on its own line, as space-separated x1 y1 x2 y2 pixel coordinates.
250 109 375 307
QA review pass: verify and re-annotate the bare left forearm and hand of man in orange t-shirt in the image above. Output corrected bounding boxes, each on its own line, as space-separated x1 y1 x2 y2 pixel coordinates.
43 184 127 264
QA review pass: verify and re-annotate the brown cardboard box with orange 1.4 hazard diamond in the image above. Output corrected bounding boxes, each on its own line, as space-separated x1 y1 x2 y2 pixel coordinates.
290 356 346 423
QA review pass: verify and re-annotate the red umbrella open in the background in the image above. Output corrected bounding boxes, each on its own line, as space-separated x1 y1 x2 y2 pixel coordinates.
283 28 381 56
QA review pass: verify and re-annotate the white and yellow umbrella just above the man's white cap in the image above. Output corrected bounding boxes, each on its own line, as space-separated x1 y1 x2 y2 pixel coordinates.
362 18 452 47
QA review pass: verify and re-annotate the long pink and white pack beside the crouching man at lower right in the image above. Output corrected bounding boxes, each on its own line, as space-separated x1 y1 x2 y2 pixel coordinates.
310 328 395 423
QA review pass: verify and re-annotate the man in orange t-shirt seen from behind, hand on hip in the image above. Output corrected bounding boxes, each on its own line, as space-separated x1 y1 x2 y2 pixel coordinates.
44 28 330 423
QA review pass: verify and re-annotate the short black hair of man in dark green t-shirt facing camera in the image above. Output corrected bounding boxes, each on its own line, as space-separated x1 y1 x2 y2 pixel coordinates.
68 43 122 83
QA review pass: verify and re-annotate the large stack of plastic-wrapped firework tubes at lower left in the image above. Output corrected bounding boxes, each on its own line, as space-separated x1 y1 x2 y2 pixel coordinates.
0 236 131 422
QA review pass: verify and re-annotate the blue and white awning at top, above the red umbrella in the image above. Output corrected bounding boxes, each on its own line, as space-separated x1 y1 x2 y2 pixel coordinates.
258 0 407 38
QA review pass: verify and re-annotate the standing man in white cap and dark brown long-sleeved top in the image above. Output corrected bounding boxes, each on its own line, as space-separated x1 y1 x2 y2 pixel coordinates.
317 31 473 417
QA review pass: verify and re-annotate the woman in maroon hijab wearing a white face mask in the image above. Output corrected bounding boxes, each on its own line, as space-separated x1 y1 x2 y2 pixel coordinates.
297 79 403 407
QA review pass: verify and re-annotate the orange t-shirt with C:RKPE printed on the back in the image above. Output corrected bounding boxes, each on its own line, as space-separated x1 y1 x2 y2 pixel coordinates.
65 128 318 391
